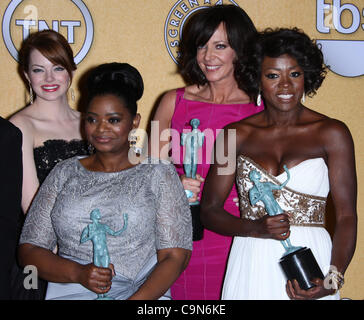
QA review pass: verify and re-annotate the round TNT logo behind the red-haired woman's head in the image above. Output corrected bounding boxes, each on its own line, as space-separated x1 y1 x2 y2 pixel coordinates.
2 0 94 64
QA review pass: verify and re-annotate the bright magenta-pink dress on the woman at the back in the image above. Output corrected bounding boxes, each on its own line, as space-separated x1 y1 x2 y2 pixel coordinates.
171 88 263 300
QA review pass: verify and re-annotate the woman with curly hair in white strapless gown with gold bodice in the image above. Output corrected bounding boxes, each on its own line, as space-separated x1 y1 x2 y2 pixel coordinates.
201 29 357 299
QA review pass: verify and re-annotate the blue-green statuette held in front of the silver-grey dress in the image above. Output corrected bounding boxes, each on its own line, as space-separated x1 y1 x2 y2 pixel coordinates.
81 209 128 300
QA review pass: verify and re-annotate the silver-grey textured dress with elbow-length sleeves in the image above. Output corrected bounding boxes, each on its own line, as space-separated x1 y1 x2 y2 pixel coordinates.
20 157 192 299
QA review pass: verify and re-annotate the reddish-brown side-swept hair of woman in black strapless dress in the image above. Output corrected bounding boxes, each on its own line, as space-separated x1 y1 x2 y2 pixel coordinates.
19 30 77 81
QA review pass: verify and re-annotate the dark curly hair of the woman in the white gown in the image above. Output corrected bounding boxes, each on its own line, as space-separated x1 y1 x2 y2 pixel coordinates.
240 28 327 101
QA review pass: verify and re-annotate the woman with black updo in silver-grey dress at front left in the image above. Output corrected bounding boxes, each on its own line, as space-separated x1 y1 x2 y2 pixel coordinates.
19 63 192 299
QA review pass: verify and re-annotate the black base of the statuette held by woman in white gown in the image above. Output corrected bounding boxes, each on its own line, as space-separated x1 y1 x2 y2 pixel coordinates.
279 247 324 290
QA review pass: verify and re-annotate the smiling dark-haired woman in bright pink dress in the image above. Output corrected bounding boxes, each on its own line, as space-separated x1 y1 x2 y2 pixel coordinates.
151 5 263 300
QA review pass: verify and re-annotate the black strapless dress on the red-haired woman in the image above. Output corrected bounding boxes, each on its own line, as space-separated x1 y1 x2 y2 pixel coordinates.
12 139 89 300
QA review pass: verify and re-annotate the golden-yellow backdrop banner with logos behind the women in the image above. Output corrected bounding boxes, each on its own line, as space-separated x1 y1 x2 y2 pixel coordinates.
0 0 364 299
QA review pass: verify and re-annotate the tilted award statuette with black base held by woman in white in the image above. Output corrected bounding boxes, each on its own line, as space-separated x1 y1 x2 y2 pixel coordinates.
249 165 324 290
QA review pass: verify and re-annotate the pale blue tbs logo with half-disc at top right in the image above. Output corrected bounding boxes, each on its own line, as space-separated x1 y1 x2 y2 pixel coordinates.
316 0 364 77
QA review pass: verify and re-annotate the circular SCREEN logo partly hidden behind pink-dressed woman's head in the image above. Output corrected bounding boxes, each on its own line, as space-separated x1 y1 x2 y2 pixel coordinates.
164 0 238 63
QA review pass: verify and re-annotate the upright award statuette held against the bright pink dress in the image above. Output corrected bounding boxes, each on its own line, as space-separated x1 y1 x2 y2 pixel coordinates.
181 119 204 241
